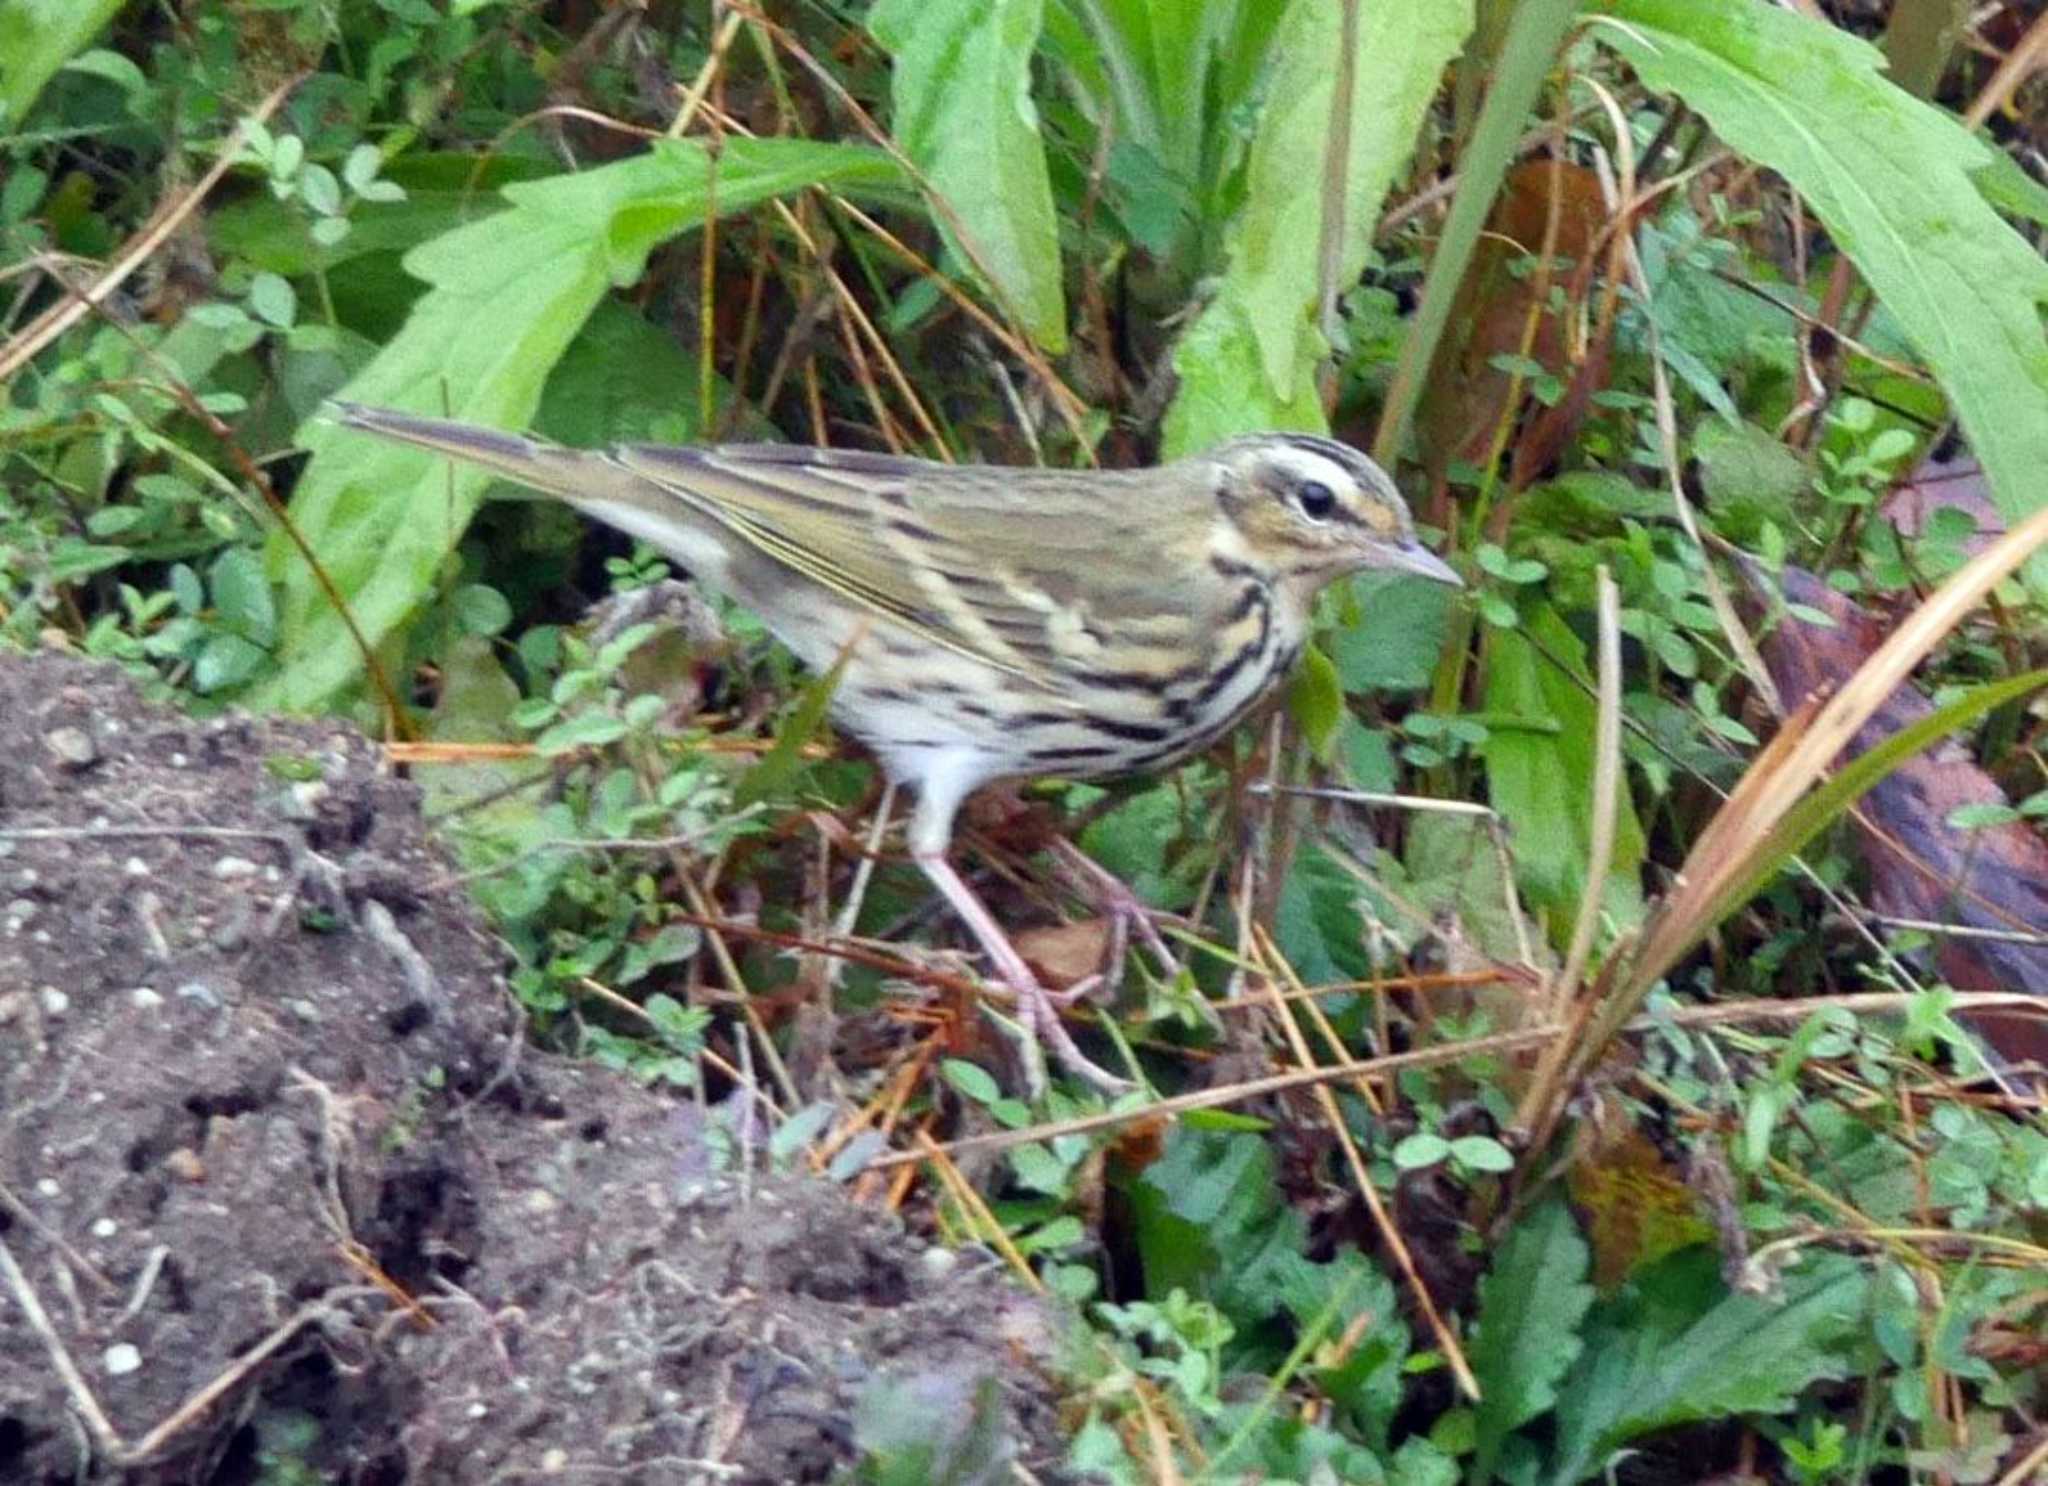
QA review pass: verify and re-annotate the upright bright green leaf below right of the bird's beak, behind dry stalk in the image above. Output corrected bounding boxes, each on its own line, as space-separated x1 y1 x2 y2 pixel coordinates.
1481 604 1645 925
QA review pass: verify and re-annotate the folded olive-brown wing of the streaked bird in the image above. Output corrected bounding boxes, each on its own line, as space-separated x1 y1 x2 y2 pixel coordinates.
610 444 1214 692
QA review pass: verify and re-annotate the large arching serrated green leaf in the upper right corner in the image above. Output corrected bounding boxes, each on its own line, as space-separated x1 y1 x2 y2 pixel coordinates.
1597 0 2048 583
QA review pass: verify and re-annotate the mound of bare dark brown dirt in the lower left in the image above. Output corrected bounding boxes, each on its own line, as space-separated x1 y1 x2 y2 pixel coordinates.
0 655 1069 1486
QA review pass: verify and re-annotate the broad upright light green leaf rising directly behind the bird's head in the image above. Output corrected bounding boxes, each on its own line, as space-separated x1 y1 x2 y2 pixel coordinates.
1165 0 1473 456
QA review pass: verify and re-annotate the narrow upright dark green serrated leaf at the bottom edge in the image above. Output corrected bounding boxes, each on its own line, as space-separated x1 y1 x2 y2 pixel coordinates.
1470 1197 1593 1480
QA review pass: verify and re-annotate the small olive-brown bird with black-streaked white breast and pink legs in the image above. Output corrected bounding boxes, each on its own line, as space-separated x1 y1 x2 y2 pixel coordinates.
330 401 1462 1093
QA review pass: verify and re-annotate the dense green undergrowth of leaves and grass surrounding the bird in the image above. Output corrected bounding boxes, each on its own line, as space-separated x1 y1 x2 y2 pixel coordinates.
0 0 2048 1484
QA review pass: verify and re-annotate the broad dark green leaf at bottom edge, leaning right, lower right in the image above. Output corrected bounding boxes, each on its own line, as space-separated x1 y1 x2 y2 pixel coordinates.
1550 1247 1870 1486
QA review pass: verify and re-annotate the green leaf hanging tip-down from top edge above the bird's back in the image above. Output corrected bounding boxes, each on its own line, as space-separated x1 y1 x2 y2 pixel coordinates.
868 0 1067 354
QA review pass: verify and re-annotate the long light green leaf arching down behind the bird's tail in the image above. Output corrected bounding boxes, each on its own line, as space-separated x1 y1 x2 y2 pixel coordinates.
256 139 903 708
